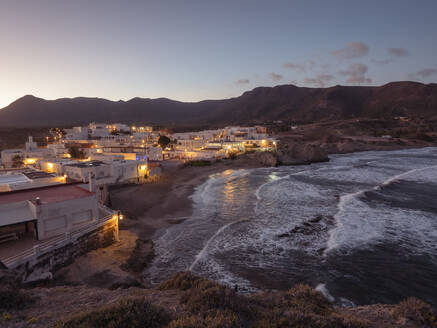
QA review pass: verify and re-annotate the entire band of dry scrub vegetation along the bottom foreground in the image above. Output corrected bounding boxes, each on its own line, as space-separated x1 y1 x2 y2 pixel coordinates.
52 273 437 328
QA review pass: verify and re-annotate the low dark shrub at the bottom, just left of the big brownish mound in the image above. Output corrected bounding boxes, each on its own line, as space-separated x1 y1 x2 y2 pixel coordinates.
58 298 171 328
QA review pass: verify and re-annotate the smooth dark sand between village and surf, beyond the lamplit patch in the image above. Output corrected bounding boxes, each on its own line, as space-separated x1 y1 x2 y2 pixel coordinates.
110 160 259 239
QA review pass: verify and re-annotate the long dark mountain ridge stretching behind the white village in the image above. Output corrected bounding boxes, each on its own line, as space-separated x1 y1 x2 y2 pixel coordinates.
0 82 437 127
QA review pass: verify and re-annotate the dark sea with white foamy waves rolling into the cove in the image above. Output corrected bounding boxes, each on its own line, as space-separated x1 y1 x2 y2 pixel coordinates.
147 148 437 306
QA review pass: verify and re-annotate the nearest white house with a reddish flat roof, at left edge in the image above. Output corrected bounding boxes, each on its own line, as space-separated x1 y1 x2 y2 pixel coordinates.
0 184 99 242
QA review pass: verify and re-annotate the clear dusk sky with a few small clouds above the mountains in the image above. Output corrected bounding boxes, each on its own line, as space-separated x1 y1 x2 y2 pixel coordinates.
0 0 437 108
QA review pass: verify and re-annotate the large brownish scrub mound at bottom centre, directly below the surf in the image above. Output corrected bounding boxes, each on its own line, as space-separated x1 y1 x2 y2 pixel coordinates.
160 272 368 328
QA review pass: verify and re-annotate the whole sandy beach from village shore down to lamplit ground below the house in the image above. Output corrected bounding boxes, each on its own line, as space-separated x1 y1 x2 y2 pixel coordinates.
54 158 266 288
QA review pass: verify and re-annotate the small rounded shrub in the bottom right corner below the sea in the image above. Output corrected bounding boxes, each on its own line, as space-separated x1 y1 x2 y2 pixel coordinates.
393 297 437 327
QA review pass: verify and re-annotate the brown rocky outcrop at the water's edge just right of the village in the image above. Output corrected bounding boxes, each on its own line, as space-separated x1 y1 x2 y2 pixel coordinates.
276 139 329 165
